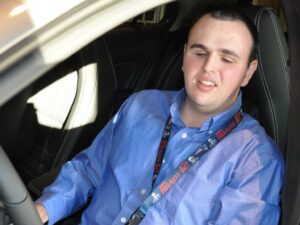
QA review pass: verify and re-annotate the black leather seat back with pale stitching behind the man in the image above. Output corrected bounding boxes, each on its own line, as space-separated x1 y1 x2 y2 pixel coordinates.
243 6 290 155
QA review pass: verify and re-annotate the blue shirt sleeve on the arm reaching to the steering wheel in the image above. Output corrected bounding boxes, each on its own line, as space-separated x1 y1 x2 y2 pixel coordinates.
36 94 134 225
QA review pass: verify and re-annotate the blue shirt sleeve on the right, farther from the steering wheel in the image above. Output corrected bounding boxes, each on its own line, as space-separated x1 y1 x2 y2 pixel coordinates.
212 136 284 225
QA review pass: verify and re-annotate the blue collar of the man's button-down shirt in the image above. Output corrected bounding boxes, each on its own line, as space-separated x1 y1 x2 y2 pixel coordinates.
170 88 242 131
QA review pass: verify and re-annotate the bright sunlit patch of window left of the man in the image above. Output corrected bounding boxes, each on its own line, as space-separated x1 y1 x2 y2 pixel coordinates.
27 63 98 130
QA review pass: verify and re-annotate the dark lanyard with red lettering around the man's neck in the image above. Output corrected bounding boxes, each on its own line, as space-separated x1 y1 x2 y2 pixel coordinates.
126 110 243 225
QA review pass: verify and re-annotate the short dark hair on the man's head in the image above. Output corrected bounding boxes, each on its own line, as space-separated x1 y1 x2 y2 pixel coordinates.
188 5 258 64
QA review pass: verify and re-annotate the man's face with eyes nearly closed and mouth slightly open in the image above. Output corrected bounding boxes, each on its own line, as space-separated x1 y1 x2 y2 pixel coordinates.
183 15 257 115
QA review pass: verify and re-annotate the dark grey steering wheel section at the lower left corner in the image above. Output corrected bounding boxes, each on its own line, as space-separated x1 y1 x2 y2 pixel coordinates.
0 146 42 225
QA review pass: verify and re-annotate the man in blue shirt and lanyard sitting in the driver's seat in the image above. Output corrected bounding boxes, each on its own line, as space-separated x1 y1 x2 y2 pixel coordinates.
37 5 283 225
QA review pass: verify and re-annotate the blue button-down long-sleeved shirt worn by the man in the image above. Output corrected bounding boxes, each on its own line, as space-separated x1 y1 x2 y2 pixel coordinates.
38 90 283 225
